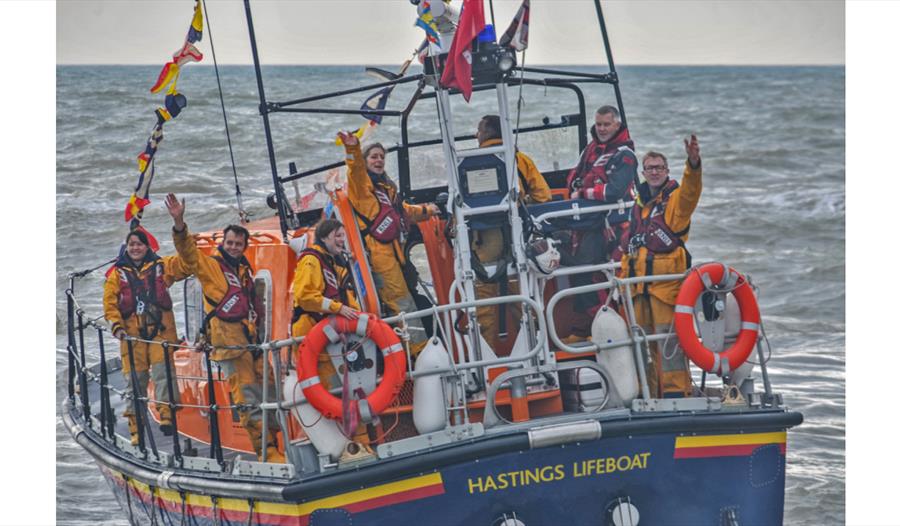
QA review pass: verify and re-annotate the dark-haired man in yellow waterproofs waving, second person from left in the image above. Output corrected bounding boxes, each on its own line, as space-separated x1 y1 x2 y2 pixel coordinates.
166 194 284 462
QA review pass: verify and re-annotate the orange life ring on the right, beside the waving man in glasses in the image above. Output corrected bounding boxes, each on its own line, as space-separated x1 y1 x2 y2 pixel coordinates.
675 263 759 376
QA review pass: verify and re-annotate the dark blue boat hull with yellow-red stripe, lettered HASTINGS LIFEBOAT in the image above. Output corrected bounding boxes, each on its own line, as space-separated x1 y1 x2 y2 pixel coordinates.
82 429 786 526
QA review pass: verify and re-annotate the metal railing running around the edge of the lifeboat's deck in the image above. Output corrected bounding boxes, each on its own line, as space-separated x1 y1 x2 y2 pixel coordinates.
66 250 772 476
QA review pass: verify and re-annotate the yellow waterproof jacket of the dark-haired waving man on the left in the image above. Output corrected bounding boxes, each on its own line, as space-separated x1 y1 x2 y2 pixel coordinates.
172 227 256 360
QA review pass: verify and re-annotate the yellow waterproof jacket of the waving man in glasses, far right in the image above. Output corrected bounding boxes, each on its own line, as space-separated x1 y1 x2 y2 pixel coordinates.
621 161 703 305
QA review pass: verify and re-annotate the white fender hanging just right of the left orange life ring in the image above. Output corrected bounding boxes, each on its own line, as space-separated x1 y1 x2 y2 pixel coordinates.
413 338 450 434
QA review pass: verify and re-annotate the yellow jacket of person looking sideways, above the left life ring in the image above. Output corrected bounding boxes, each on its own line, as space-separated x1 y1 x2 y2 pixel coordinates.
291 244 359 336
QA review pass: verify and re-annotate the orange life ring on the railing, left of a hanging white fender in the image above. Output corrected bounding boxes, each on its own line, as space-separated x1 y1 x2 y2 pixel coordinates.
297 314 406 420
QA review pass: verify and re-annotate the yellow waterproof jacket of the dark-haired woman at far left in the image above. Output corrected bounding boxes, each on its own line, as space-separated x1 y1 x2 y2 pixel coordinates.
103 256 191 342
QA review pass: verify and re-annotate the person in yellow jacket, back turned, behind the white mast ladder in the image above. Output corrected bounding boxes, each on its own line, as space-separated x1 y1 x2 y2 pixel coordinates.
472 115 552 350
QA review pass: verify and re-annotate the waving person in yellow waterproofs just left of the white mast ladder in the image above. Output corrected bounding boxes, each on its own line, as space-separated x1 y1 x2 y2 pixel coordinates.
338 132 438 356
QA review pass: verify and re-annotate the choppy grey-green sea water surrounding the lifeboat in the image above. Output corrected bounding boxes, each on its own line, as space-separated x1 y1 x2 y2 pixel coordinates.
56 64 845 526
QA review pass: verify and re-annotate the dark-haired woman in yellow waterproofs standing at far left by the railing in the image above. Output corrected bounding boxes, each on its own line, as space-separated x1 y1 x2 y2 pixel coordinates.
103 229 191 445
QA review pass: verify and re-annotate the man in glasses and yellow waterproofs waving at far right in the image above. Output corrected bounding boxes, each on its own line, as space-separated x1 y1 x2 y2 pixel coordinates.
621 135 703 398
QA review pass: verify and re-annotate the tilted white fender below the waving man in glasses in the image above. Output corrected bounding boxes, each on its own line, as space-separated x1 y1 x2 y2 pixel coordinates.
591 306 639 407
